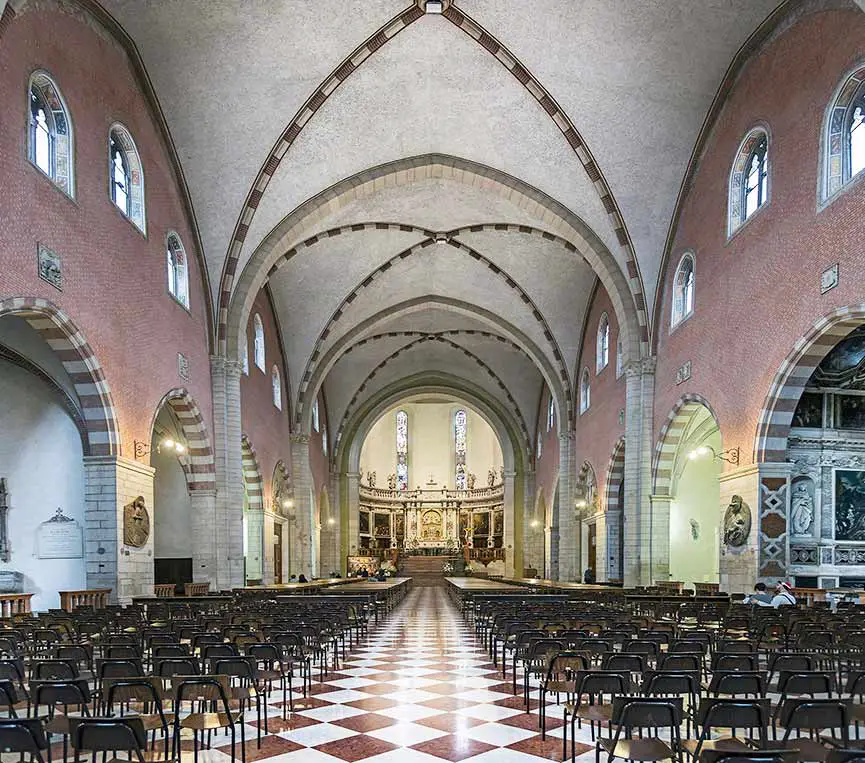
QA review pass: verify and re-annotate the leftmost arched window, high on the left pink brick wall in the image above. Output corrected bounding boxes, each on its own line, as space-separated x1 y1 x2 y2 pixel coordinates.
27 72 73 196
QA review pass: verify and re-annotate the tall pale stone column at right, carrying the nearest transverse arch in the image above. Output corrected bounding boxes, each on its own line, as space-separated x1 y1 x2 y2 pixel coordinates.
622 358 656 588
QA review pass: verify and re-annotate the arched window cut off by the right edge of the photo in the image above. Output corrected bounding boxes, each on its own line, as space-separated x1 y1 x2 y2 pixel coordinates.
823 67 865 199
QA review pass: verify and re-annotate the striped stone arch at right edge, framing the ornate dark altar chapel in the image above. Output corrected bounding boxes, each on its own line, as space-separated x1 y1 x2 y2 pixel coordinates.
754 303 865 464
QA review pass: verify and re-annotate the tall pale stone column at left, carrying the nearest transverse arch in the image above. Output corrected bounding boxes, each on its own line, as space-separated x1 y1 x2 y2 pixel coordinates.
210 356 246 590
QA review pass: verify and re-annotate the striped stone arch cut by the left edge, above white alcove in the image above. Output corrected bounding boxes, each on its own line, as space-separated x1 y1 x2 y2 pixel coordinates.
0 297 120 456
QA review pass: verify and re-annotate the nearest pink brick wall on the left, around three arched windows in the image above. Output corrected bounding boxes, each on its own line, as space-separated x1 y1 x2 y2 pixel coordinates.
0 3 212 457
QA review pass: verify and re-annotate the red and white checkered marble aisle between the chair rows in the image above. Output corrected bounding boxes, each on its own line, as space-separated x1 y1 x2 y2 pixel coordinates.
230 588 594 763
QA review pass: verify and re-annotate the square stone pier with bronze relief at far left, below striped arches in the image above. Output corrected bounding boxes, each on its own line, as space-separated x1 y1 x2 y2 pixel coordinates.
84 456 156 604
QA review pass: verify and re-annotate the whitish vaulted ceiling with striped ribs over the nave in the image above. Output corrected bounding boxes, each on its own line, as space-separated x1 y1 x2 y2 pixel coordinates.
94 0 778 447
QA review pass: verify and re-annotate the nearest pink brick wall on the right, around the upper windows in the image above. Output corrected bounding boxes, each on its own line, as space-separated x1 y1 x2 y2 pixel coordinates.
654 8 865 464
